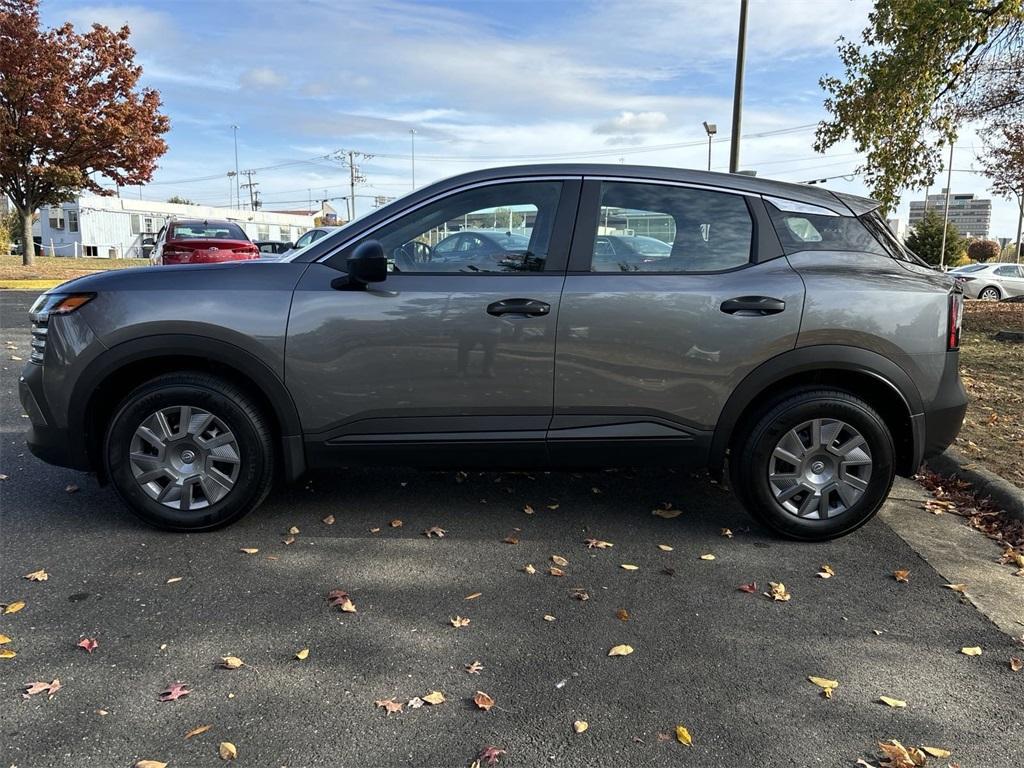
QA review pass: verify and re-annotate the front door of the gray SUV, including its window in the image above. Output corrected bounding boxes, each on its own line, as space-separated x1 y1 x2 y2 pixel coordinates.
286 178 581 466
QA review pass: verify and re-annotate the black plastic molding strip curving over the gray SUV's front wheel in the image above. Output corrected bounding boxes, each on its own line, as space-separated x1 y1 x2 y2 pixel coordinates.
69 334 306 481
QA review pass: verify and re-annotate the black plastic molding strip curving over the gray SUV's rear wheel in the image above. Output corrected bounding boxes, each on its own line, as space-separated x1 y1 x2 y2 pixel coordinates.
709 344 925 470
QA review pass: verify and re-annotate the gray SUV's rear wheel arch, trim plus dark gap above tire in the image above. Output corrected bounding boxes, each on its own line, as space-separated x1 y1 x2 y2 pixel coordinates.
709 345 924 475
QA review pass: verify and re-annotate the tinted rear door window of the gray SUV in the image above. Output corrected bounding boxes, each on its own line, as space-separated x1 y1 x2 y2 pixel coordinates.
591 181 754 272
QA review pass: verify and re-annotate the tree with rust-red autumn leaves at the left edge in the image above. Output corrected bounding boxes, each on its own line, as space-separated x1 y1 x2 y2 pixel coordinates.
0 0 170 265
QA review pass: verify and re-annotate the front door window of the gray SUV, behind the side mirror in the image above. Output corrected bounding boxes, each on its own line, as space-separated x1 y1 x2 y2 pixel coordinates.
354 181 561 273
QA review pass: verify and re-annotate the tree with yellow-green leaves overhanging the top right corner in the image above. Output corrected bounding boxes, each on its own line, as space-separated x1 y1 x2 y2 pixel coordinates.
815 0 1024 208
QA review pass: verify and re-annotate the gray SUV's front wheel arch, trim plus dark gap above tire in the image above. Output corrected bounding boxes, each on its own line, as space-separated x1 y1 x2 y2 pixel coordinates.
69 334 305 481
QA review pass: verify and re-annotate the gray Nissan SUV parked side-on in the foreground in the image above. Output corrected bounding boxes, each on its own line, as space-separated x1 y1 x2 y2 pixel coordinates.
20 165 966 540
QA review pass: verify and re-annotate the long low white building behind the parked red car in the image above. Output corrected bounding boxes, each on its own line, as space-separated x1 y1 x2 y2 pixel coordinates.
39 195 313 258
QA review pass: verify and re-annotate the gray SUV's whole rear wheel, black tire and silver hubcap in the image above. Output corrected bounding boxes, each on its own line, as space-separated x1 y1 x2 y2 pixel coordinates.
730 389 895 541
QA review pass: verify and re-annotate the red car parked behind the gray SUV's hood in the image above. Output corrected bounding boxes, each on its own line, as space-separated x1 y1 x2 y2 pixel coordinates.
150 219 259 264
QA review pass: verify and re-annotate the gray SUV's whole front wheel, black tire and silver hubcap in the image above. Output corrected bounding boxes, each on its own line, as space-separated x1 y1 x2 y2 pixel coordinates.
104 373 273 530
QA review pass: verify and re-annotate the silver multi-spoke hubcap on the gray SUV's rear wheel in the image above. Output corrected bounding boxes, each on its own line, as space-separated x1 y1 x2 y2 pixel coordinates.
768 419 871 520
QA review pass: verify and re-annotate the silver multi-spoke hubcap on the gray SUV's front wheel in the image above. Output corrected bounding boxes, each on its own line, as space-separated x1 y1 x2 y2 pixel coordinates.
128 406 242 511
